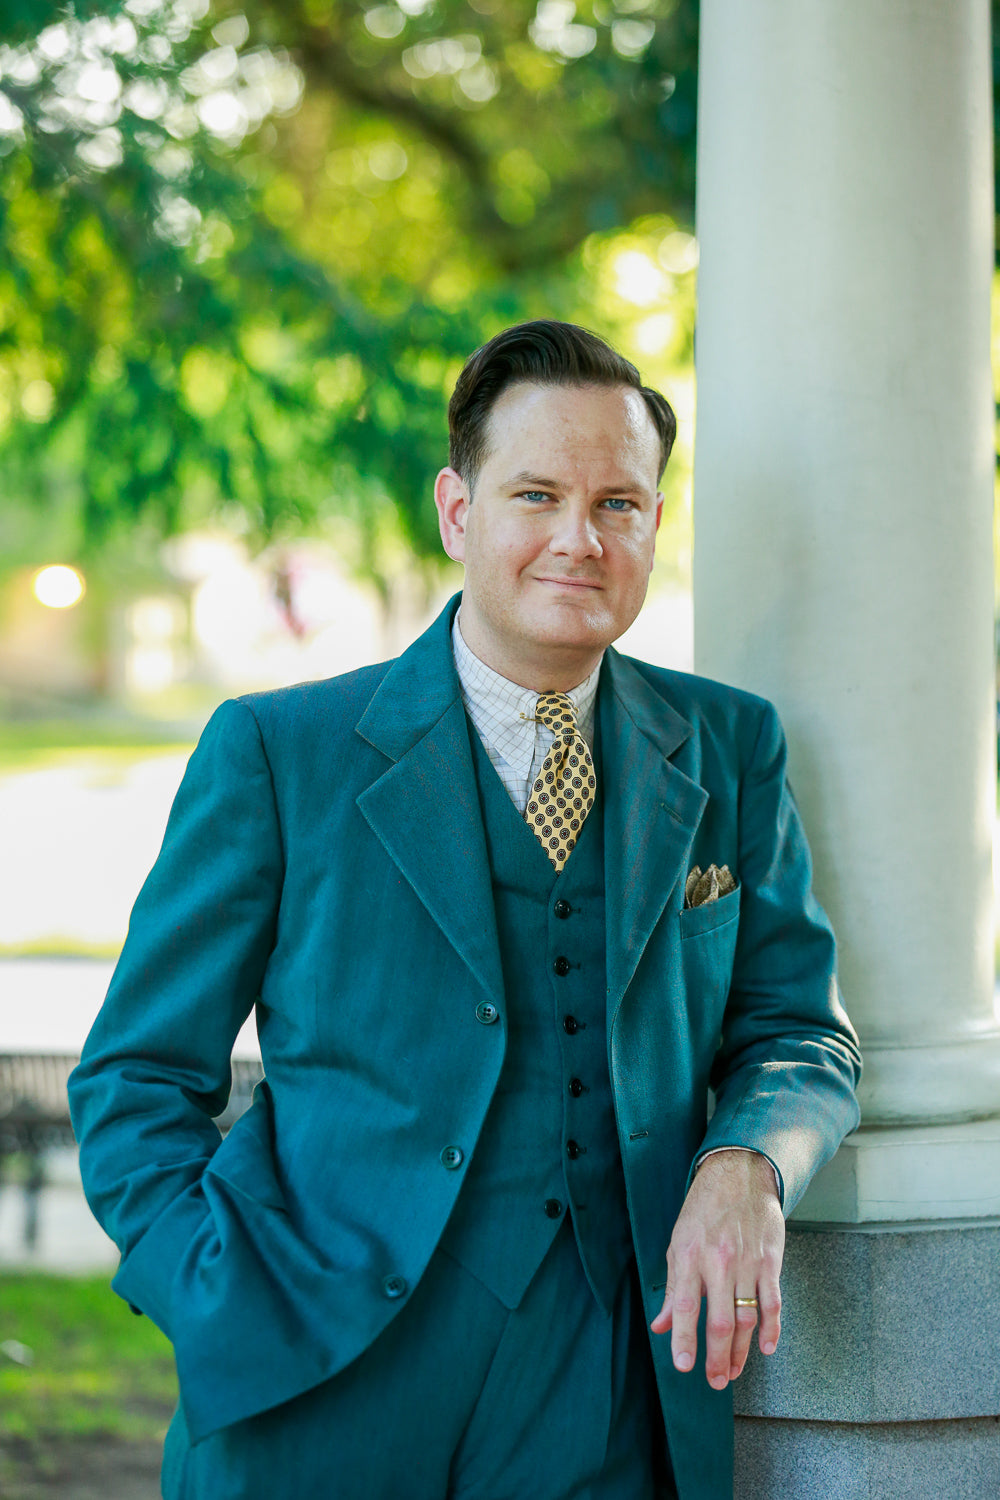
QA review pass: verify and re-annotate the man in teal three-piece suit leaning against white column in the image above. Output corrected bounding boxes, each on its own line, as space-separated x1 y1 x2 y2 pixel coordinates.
72 321 858 1500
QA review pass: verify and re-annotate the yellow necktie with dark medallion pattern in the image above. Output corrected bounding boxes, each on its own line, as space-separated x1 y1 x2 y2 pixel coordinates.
525 693 597 872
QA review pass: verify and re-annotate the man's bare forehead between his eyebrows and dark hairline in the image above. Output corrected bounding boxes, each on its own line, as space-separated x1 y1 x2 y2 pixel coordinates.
484 381 660 488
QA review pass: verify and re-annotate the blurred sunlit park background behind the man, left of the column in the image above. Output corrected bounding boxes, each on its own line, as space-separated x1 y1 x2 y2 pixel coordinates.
0 0 1000 1500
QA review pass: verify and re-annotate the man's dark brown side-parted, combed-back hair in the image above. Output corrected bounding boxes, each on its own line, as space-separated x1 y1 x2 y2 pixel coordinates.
448 318 678 491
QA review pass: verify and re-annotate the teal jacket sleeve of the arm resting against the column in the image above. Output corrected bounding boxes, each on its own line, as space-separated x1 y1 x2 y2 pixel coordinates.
697 705 861 1214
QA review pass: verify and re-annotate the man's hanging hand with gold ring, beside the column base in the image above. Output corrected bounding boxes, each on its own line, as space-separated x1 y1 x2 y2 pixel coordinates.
651 1151 784 1391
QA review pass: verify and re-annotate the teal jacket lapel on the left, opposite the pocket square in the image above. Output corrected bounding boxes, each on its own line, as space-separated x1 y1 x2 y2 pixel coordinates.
357 621 504 1005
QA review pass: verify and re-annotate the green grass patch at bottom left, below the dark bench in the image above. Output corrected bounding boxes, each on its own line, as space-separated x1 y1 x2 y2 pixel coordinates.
0 1272 177 1452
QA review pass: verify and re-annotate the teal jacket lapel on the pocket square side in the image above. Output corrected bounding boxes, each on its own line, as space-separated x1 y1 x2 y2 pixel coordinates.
601 651 708 1028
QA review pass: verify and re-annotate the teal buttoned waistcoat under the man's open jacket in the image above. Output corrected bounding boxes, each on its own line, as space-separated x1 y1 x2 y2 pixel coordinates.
441 726 631 1311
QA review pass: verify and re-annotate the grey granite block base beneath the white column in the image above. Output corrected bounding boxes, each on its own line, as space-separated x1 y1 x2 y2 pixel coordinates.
735 1220 1000 1500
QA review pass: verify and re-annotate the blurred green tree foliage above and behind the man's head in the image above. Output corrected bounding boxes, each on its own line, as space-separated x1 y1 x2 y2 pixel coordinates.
0 0 697 590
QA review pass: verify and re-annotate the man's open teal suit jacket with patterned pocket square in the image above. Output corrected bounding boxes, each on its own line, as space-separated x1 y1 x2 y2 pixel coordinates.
70 602 859 1500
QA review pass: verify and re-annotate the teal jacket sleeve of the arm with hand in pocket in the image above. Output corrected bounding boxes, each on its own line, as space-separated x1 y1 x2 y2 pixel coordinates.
69 702 283 1335
